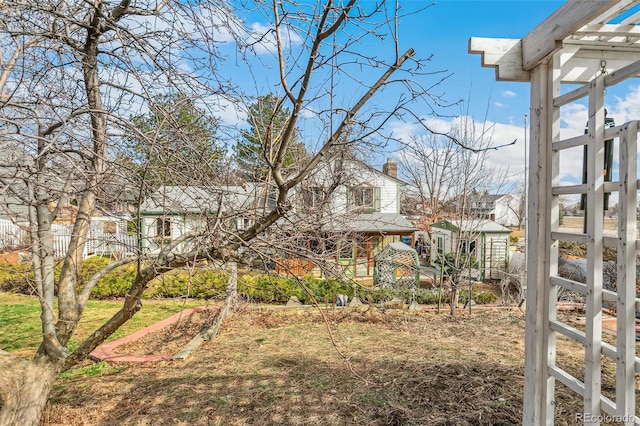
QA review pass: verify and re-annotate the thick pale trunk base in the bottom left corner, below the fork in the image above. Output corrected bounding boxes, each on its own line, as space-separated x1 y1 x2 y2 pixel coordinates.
0 351 58 426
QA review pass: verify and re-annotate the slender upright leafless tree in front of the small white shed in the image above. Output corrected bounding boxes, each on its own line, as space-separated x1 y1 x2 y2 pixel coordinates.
401 114 506 314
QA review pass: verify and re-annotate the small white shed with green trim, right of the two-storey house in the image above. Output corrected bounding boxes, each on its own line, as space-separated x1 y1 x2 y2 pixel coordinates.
431 219 511 281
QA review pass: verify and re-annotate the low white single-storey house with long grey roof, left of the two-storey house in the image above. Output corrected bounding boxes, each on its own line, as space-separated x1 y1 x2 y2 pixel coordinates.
140 183 274 252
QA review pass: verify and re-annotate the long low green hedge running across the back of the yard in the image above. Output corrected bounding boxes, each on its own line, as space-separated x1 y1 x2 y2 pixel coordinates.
0 257 497 304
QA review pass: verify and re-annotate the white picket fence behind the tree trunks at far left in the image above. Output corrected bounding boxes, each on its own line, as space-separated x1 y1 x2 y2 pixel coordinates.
0 219 138 259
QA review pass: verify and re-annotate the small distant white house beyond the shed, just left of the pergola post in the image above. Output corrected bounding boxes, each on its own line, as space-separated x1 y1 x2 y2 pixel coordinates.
466 192 521 226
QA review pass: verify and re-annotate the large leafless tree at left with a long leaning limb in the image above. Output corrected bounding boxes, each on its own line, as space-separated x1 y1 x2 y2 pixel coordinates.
0 0 444 425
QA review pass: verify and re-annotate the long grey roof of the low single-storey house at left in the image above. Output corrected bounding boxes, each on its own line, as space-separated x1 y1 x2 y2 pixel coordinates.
140 183 276 215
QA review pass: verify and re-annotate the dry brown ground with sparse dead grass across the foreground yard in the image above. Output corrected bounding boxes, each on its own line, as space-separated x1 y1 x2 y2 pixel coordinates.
43 308 636 426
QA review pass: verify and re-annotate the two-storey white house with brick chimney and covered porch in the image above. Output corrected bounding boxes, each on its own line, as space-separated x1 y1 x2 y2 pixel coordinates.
277 159 416 283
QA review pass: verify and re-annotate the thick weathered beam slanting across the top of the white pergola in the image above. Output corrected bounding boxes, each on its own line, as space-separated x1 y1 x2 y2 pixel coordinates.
522 0 630 71
